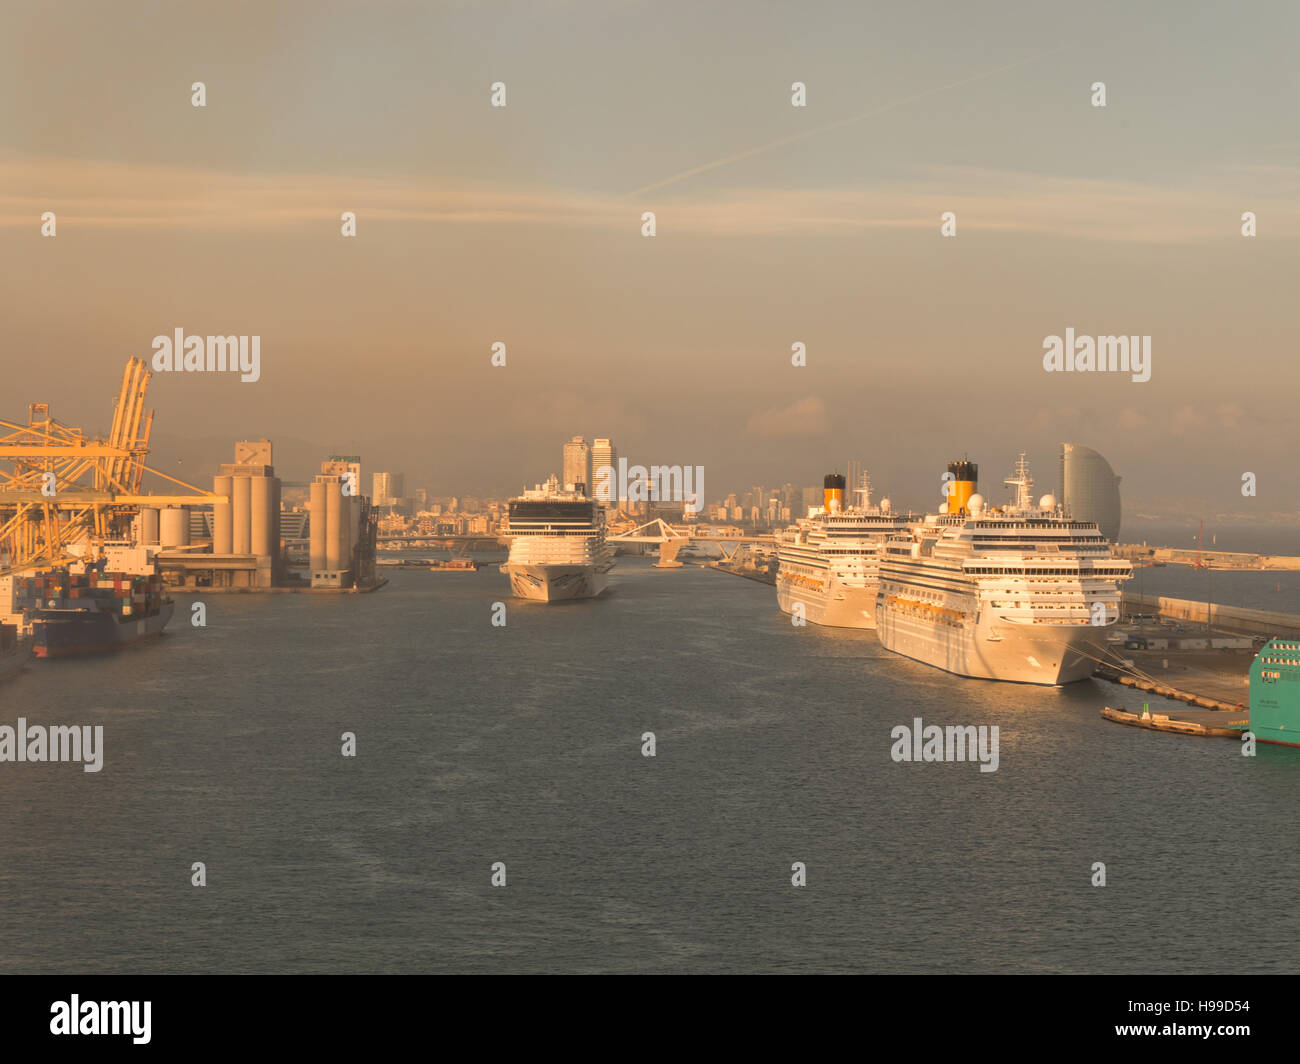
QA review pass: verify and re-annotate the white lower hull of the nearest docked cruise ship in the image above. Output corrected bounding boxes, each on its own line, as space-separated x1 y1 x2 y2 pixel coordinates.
876 602 1106 687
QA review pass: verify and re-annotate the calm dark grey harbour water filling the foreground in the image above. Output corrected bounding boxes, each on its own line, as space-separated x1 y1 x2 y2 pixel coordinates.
0 558 1300 972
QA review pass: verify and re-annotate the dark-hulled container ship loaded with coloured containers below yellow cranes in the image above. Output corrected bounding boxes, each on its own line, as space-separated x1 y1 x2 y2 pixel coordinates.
14 562 174 658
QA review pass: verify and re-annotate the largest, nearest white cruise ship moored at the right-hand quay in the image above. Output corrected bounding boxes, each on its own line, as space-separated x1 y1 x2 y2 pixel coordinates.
876 454 1132 684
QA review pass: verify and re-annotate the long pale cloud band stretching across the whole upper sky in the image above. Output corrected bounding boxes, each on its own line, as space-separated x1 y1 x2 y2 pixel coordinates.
0 160 1300 245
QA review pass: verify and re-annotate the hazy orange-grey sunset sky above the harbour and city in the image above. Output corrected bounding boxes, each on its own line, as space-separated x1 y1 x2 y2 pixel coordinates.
0 0 1300 516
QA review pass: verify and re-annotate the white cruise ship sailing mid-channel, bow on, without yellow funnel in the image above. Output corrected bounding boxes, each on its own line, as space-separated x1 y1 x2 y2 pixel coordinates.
501 476 614 602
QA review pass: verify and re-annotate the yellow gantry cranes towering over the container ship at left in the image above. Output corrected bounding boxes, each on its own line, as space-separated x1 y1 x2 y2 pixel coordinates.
0 358 226 576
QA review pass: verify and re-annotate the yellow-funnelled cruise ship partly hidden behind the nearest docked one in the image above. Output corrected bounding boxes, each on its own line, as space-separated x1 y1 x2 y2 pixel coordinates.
776 473 919 628
